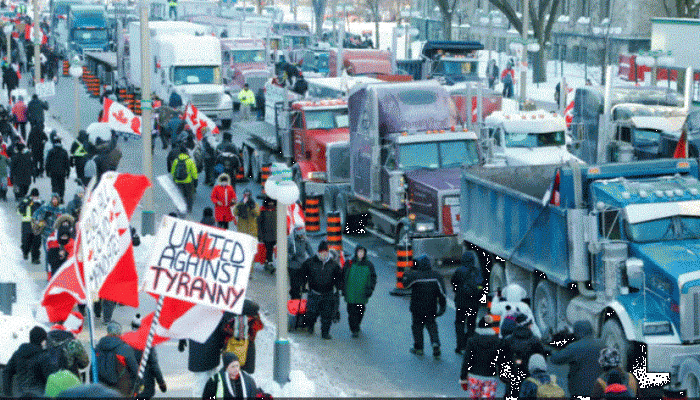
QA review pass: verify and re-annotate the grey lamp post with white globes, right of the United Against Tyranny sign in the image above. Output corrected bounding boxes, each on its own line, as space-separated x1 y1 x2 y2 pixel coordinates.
265 163 299 385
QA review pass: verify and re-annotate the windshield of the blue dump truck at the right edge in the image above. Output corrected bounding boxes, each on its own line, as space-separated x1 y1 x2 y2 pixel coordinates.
627 215 700 242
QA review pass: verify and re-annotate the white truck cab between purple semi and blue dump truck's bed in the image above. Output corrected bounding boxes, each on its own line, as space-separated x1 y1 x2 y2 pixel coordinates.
484 110 581 166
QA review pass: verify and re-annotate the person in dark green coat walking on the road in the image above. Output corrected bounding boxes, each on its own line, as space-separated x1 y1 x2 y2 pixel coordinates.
343 246 377 337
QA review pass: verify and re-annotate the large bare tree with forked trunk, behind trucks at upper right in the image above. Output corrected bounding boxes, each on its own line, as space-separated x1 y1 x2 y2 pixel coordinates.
489 0 560 83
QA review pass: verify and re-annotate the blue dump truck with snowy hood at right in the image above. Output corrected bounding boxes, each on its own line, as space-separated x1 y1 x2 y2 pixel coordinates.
459 159 700 397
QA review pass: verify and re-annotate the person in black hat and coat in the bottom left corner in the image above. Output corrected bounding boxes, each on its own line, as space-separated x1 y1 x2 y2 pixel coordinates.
2 326 46 397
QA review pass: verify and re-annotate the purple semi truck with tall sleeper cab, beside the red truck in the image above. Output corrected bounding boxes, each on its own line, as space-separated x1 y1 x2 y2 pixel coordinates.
323 81 482 262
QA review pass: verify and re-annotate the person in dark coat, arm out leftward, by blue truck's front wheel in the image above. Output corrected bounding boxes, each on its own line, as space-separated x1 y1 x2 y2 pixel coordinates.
549 320 604 397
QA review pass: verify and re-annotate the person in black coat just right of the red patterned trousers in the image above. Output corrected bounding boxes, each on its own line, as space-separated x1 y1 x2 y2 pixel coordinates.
498 314 544 397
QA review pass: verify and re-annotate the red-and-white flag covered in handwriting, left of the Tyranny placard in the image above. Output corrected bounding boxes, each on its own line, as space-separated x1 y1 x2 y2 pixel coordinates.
79 171 150 307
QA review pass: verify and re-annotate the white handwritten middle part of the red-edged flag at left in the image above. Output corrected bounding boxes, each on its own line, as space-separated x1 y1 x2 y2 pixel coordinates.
80 172 131 293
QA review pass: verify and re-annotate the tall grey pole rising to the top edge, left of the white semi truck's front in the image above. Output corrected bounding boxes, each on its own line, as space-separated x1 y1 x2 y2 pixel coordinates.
139 0 155 235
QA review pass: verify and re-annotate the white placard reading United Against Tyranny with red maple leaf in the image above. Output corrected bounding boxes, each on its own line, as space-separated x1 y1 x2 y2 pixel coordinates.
144 216 257 314
